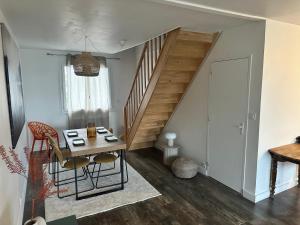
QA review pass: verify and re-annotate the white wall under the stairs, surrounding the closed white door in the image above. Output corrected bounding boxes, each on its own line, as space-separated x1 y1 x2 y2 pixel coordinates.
160 22 265 201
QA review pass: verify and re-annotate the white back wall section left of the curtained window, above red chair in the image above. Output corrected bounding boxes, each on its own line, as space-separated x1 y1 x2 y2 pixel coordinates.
21 49 67 146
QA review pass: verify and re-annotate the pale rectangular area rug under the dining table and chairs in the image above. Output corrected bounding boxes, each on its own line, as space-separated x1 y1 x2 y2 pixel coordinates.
44 161 161 221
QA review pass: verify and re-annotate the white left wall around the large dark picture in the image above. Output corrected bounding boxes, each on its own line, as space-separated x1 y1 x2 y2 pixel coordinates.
0 12 27 225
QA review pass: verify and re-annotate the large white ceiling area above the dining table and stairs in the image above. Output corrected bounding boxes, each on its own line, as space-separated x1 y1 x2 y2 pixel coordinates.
0 0 251 53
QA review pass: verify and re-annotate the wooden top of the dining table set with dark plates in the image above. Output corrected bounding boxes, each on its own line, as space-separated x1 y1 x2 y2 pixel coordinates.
63 128 126 157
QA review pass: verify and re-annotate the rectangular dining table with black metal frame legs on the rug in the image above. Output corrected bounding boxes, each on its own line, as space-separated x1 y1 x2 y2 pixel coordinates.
63 127 126 200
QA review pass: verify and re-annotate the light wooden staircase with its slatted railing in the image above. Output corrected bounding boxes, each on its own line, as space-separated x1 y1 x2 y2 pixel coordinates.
124 28 217 150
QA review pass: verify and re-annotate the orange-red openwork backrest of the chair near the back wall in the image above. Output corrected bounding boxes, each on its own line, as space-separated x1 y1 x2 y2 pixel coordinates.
28 121 58 140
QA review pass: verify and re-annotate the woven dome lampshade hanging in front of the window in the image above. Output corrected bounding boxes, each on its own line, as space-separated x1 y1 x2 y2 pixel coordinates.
73 52 100 77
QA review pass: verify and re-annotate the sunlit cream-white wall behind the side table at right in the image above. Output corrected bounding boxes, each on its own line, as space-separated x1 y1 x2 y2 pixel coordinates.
256 20 300 201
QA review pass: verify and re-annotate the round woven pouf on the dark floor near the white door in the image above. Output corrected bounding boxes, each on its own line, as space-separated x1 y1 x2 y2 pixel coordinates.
172 157 198 179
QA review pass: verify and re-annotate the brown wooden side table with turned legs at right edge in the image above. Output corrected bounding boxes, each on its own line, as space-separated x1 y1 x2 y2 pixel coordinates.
269 144 300 198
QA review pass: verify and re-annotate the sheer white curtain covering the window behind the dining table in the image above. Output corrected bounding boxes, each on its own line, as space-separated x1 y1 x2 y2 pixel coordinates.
64 59 111 129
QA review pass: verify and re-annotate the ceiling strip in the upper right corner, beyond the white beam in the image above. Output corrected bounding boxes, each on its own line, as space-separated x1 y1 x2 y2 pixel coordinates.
158 0 300 25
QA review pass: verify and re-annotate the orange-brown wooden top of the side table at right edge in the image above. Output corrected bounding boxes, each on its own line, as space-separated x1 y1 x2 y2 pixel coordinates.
269 144 300 162
